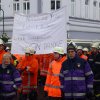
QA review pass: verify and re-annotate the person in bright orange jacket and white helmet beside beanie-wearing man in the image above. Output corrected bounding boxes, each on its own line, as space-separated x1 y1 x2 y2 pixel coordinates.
44 47 66 100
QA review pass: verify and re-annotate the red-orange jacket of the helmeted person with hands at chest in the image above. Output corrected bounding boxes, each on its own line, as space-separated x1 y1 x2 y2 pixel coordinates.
18 56 38 94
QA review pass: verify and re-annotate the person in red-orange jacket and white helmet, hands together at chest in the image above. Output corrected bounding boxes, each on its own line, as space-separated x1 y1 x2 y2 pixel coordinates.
17 48 38 100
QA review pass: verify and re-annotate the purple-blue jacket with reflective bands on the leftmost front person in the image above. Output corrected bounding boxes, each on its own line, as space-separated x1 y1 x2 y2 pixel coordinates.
0 64 21 97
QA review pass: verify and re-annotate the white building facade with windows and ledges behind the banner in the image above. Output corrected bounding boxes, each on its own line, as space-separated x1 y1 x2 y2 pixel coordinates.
0 0 100 41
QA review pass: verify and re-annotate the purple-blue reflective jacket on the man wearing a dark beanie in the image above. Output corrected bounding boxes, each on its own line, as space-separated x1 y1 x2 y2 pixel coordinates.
60 56 93 98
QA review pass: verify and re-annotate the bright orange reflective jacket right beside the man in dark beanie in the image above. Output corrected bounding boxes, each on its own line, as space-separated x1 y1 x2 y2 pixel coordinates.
44 57 66 97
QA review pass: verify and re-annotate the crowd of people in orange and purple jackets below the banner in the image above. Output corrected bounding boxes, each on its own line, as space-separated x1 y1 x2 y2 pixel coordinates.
0 39 100 100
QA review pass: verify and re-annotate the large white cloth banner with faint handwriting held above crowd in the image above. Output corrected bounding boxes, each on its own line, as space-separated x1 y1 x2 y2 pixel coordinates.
11 8 67 54
